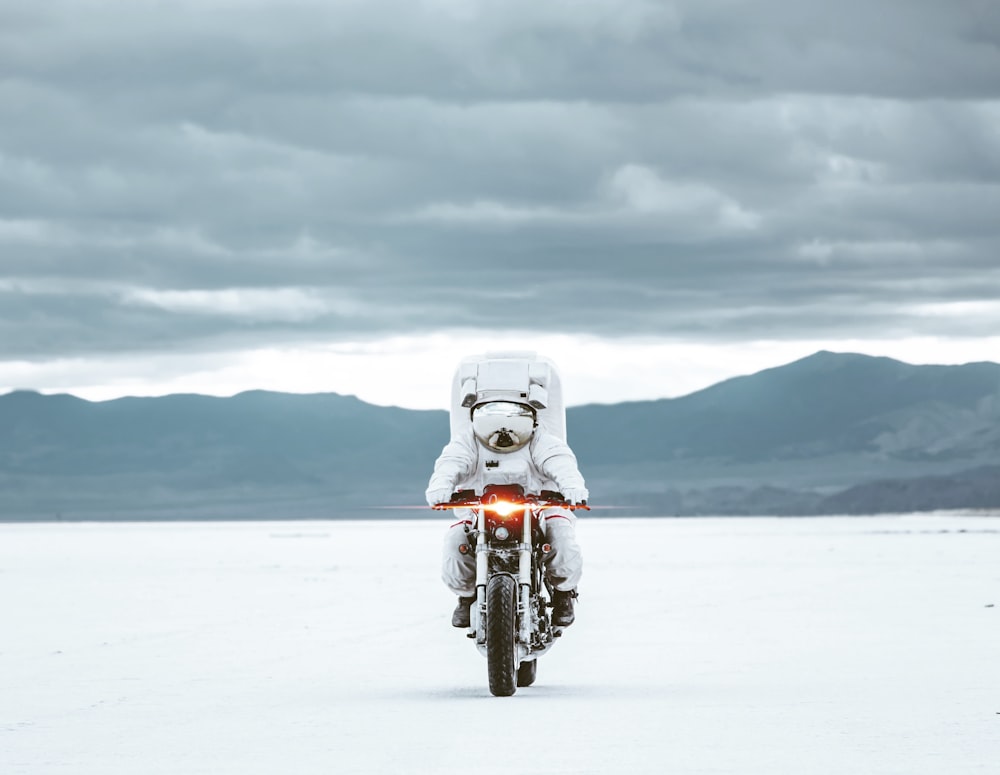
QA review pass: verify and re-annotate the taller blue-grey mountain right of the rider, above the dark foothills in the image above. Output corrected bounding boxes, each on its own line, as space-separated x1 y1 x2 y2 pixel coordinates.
570 352 1000 513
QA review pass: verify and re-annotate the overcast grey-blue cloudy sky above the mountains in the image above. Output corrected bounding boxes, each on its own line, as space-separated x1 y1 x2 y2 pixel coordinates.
0 0 1000 407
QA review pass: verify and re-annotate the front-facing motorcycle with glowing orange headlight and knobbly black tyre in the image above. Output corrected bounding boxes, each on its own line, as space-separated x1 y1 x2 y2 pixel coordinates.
433 484 589 697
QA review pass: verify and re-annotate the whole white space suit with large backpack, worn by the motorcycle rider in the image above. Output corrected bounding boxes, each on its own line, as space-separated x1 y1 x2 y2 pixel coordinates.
426 353 589 627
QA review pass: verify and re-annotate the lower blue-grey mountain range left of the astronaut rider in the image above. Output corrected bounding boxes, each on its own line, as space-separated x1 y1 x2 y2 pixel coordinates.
0 391 448 518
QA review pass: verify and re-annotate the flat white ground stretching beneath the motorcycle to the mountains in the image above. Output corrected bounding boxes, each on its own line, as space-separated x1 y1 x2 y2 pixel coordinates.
0 515 1000 775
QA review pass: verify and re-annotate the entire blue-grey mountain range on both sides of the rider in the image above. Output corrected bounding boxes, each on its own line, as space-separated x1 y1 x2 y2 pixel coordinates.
0 352 1000 519
